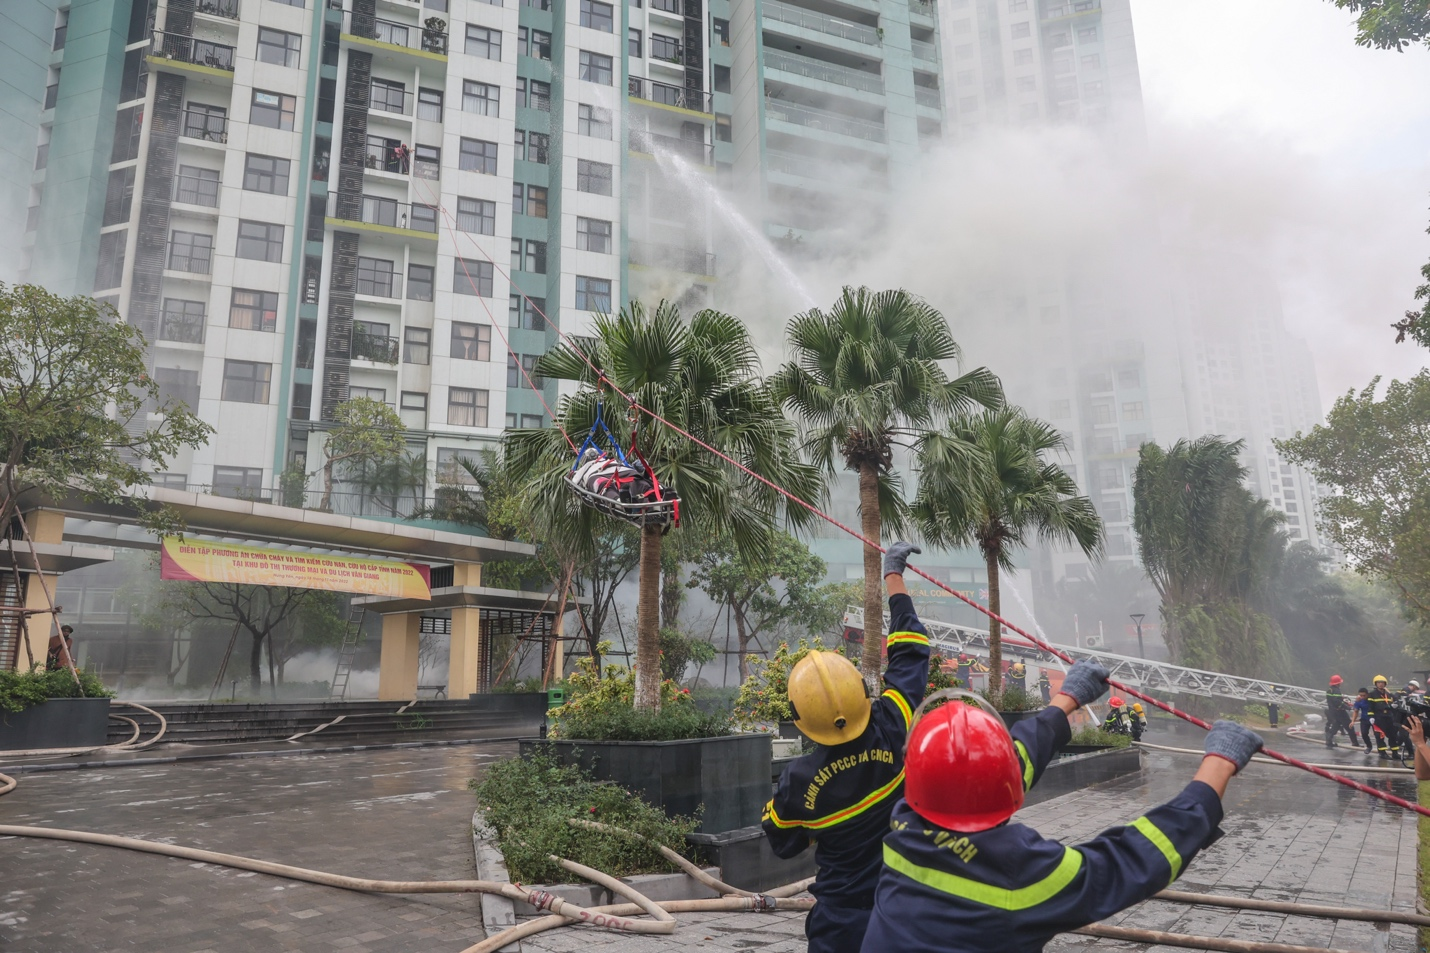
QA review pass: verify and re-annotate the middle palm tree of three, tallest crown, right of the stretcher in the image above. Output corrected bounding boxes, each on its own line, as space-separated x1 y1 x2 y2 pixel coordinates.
769 288 1002 677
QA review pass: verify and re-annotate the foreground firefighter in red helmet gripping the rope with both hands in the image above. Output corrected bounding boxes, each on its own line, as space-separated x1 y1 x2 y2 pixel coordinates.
862 672 1261 953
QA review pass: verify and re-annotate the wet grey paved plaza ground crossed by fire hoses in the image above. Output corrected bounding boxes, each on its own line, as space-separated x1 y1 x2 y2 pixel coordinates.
0 724 1417 953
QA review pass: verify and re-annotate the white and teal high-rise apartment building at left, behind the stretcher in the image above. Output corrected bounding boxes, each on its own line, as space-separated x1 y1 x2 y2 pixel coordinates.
0 0 716 503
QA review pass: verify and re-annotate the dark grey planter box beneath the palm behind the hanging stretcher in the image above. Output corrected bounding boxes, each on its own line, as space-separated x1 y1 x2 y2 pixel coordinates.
521 734 771 833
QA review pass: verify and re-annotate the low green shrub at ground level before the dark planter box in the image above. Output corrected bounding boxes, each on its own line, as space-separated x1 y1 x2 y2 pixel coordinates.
468 754 699 883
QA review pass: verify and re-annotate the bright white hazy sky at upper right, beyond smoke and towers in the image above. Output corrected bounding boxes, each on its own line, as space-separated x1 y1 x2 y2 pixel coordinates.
1131 0 1430 405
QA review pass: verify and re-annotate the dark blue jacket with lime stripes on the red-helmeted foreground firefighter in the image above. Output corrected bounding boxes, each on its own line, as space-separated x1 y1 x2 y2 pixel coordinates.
864 708 1221 953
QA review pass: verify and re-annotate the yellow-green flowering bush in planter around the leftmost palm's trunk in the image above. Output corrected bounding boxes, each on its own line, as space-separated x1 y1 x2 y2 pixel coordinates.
548 642 729 741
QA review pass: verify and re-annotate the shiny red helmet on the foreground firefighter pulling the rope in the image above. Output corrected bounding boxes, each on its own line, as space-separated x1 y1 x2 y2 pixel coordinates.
904 700 1022 833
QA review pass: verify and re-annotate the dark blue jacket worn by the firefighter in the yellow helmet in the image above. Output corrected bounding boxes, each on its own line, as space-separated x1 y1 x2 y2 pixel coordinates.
762 595 928 910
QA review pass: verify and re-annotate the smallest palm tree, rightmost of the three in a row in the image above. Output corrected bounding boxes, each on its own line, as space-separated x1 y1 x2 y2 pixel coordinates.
914 406 1103 697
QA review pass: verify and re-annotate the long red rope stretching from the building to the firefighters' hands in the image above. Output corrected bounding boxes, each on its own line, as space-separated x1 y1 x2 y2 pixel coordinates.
394 176 1430 817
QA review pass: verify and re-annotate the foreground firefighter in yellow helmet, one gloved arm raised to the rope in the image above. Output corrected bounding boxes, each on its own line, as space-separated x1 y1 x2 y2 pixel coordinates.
762 542 928 953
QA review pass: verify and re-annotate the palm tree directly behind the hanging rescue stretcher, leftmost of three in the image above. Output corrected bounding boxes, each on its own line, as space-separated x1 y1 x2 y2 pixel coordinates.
509 302 822 710
